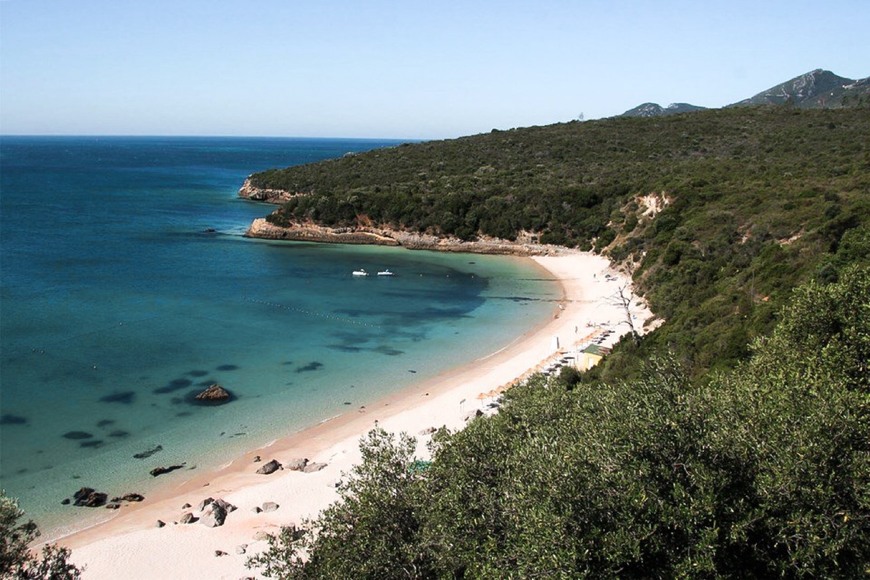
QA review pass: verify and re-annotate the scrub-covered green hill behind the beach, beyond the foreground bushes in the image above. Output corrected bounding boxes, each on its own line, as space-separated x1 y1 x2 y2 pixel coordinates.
251 107 870 378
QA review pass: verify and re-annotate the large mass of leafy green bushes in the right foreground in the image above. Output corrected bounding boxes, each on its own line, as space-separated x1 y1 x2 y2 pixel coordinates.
252 267 870 578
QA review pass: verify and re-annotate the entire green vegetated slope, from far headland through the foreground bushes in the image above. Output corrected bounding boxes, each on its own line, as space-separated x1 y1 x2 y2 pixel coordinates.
250 107 870 578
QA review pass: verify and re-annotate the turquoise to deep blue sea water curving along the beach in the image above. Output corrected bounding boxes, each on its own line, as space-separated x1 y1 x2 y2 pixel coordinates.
0 137 558 530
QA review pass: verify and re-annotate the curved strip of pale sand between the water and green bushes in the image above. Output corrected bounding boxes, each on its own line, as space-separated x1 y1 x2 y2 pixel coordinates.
58 252 650 580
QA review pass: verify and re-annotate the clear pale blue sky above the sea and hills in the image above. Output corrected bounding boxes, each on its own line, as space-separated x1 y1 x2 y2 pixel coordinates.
0 0 870 138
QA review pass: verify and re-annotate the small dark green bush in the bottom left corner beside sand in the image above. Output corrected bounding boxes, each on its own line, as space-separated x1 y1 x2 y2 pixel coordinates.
0 491 81 580
